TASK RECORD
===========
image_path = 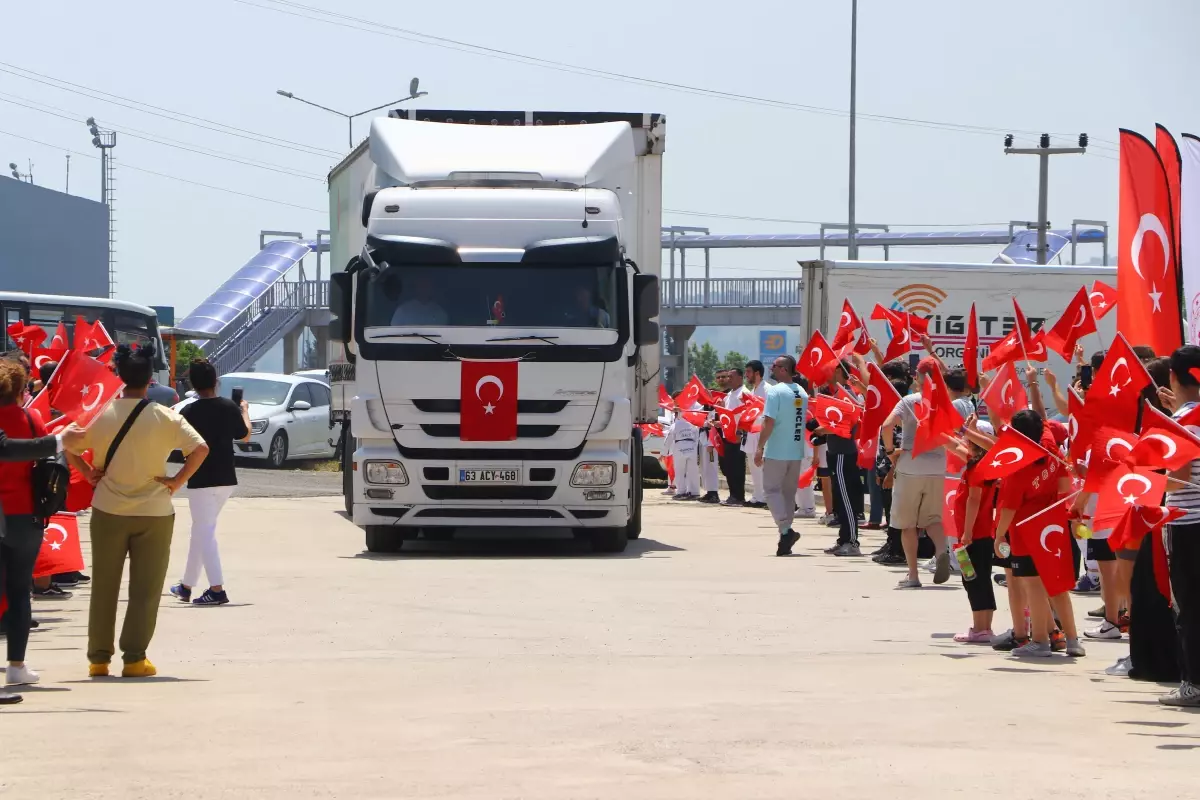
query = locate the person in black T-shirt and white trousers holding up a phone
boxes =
[170,359,250,606]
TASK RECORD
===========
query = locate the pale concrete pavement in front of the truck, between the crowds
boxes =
[0,492,1200,800]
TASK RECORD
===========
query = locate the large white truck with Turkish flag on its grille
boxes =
[330,110,666,552]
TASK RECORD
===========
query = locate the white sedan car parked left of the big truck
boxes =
[175,372,341,469]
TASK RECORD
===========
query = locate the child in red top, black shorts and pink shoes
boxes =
[954,422,1000,644]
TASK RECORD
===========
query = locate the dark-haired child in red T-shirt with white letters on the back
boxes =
[996,410,1086,657]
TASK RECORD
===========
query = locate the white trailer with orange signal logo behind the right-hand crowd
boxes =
[800,260,1118,386]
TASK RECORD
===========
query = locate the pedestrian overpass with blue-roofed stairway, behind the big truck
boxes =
[176,221,1108,373]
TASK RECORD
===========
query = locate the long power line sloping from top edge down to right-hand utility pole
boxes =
[233,0,1123,142]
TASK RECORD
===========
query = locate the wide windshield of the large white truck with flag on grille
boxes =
[366,263,617,330]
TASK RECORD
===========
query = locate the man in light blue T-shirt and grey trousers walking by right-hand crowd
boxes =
[754,355,809,555]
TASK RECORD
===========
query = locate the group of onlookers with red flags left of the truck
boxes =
[0,343,250,704]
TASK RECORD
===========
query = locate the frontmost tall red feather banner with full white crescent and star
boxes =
[1117,128,1183,354]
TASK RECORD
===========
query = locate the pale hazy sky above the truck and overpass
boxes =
[0,0,1200,314]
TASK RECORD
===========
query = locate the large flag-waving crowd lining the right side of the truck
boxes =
[665,319,1200,708]
